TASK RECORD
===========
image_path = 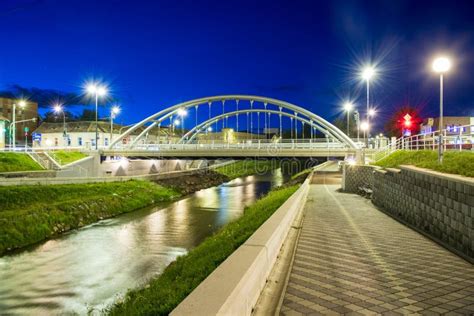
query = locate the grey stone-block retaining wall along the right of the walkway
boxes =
[343,166,474,262]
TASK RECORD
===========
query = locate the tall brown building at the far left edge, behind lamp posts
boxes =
[0,97,38,144]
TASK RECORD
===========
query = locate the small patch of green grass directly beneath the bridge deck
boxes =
[214,159,279,179]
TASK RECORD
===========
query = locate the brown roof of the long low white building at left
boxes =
[34,121,174,135]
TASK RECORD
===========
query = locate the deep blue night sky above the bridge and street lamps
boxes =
[0,0,474,129]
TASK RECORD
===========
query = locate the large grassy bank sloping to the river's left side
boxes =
[0,181,179,254]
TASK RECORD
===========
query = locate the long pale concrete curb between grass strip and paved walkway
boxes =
[171,173,312,315]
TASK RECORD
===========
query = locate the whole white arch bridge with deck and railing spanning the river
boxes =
[103,95,359,157]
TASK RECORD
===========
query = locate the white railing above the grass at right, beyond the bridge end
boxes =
[372,125,474,161]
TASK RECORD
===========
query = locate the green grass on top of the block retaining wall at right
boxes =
[374,150,474,177]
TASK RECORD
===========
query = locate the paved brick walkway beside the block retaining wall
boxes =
[281,179,474,315]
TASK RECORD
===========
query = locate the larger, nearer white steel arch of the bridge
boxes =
[109,94,358,149]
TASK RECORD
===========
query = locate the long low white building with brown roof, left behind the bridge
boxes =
[32,121,179,149]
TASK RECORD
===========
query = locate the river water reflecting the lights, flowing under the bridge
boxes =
[0,169,286,315]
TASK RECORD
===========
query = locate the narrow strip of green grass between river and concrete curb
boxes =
[106,185,298,315]
